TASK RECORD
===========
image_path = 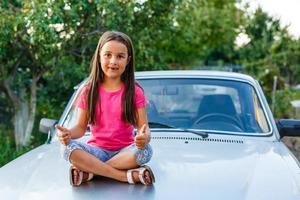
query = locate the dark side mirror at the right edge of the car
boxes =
[276,119,300,138]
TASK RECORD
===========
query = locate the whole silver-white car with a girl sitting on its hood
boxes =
[0,71,300,200]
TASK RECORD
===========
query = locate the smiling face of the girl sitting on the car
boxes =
[100,40,130,79]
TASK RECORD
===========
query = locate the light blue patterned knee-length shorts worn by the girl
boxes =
[63,140,153,165]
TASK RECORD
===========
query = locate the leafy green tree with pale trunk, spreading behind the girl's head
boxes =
[0,0,182,146]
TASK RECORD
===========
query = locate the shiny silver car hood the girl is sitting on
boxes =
[0,134,300,200]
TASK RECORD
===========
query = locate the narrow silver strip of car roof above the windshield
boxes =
[135,70,255,84]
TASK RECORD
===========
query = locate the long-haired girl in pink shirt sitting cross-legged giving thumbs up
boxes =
[56,31,155,186]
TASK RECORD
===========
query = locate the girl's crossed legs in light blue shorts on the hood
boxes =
[64,140,153,184]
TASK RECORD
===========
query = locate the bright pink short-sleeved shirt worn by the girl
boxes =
[76,85,147,150]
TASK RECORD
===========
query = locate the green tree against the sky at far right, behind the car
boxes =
[238,8,300,117]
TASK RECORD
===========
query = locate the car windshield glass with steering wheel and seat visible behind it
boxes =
[138,78,270,134]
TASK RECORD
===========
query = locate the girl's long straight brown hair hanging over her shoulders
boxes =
[87,31,137,125]
